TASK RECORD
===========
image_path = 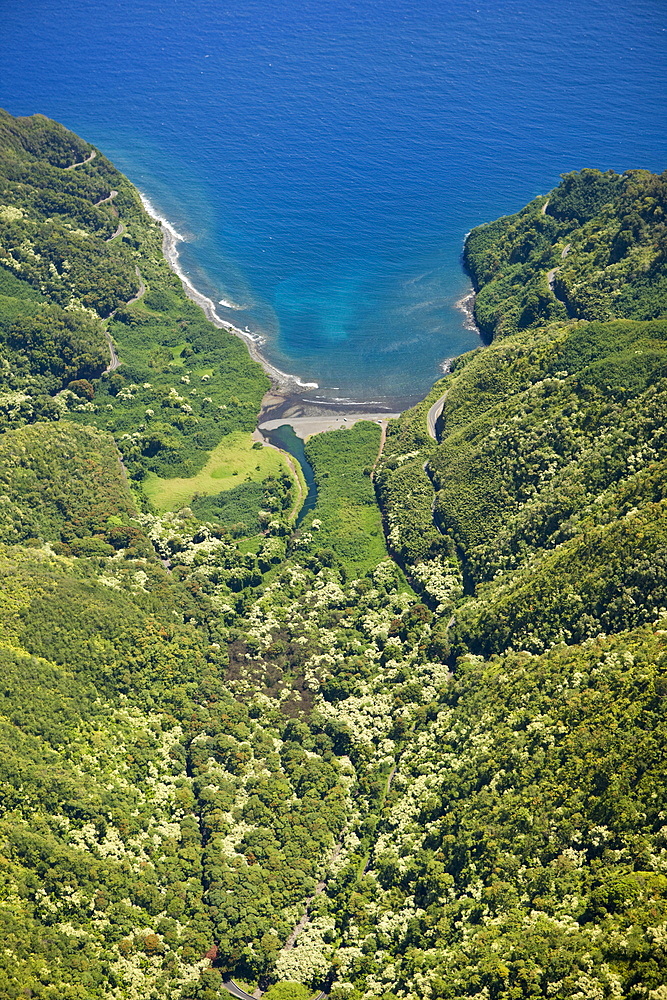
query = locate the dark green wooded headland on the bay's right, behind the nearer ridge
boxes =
[465,170,667,336]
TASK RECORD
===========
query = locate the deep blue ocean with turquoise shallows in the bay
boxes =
[0,0,667,403]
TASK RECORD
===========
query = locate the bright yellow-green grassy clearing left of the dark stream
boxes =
[143,431,286,512]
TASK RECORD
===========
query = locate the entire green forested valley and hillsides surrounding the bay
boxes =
[0,112,667,1000]
